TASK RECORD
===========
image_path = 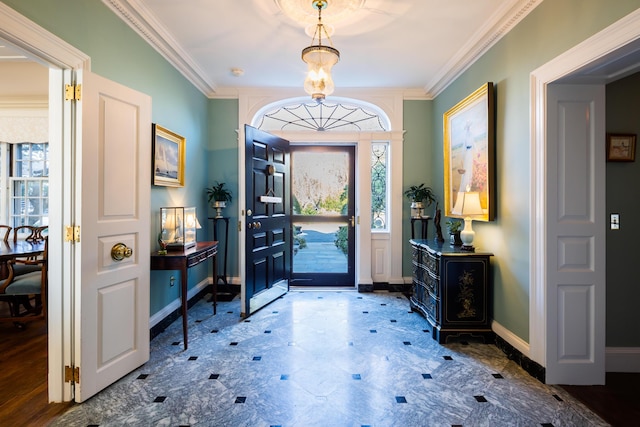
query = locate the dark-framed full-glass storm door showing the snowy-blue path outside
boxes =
[291,145,355,286]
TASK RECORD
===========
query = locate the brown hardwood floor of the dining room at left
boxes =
[0,320,72,427]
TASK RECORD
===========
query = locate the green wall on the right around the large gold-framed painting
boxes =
[432,0,640,341]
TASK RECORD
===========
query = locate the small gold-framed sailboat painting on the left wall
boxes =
[153,123,187,187]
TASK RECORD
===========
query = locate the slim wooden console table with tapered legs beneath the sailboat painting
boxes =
[151,241,218,350]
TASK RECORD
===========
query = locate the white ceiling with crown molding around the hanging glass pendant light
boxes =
[103,0,542,99]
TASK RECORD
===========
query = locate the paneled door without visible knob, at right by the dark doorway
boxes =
[546,85,606,385]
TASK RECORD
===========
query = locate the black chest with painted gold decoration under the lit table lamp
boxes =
[409,239,493,344]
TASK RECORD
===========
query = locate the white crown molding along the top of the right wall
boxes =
[424,0,543,99]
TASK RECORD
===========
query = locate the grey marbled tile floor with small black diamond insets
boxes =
[52,290,607,427]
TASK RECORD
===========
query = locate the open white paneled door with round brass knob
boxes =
[73,71,151,402]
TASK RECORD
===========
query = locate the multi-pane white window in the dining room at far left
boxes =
[9,143,49,231]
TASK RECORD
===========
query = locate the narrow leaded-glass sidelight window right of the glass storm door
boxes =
[371,142,389,231]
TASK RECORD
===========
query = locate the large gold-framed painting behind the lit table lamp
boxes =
[443,82,495,221]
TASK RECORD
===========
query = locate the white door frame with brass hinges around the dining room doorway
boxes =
[0,3,91,402]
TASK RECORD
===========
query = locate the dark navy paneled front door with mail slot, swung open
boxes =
[243,125,291,316]
